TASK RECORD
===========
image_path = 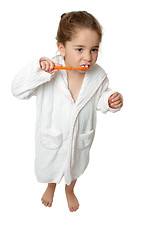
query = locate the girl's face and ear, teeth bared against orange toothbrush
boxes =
[58,29,100,73]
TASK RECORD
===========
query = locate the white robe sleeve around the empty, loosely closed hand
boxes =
[97,77,121,113]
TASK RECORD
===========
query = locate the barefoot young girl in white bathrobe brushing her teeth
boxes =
[12,11,122,212]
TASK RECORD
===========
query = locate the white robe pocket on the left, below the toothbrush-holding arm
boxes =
[40,130,62,149]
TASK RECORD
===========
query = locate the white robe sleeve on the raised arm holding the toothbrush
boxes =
[11,59,53,99]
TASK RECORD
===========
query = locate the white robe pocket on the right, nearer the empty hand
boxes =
[77,130,95,149]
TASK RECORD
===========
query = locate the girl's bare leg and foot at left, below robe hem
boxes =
[41,183,56,207]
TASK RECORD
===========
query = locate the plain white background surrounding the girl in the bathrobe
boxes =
[0,0,160,240]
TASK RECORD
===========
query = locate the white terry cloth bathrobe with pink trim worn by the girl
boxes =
[12,56,119,185]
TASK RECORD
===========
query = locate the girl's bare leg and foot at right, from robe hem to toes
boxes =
[65,180,79,212]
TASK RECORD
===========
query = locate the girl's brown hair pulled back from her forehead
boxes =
[56,11,102,46]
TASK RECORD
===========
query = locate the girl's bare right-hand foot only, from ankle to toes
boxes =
[66,191,79,212]
